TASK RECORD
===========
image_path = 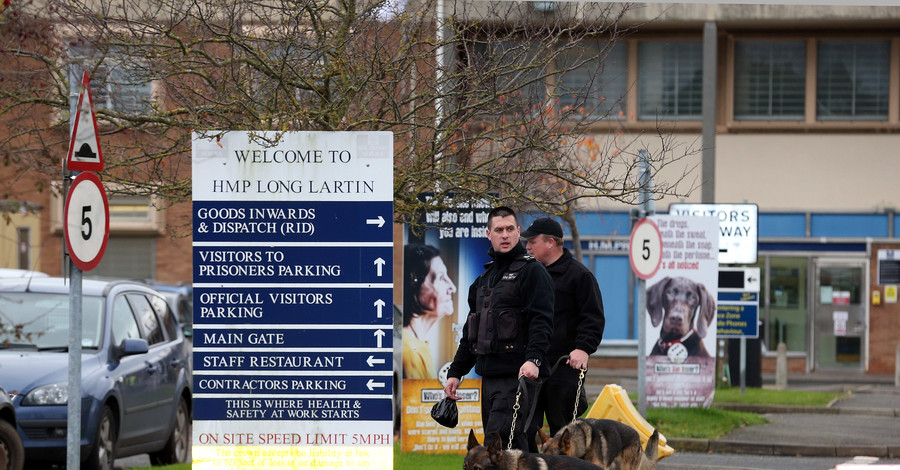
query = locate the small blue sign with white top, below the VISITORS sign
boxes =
[716,268,760,338]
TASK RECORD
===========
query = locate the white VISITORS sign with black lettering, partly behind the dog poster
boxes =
[669,204,759,264]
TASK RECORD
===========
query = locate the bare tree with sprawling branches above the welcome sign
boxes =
[0,0,695,234]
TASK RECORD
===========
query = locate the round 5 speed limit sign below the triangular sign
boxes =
[64,172,109,271]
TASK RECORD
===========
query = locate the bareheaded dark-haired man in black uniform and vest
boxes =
[444,206,553,451]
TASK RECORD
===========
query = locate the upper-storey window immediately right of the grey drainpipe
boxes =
[734,41,806,120]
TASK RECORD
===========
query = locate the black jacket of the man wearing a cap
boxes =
[547,248,606,366]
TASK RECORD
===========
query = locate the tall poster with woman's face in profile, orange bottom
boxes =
[400,205,491,454]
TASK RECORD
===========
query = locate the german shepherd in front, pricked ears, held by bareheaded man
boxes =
[463,430,602,470]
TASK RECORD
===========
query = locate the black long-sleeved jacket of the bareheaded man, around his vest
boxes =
[447,243,553,378]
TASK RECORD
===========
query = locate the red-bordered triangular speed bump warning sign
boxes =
[66,72,103,171]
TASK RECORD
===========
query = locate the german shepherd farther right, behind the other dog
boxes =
[539,418,659,470]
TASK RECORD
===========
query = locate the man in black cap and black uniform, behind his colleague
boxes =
[522,218,606,452]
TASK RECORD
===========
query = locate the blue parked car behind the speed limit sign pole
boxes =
[0,277,192,470]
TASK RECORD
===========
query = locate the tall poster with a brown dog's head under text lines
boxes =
[645,215,719,407]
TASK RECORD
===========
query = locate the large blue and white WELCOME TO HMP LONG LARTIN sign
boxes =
[192,131,393,469]
